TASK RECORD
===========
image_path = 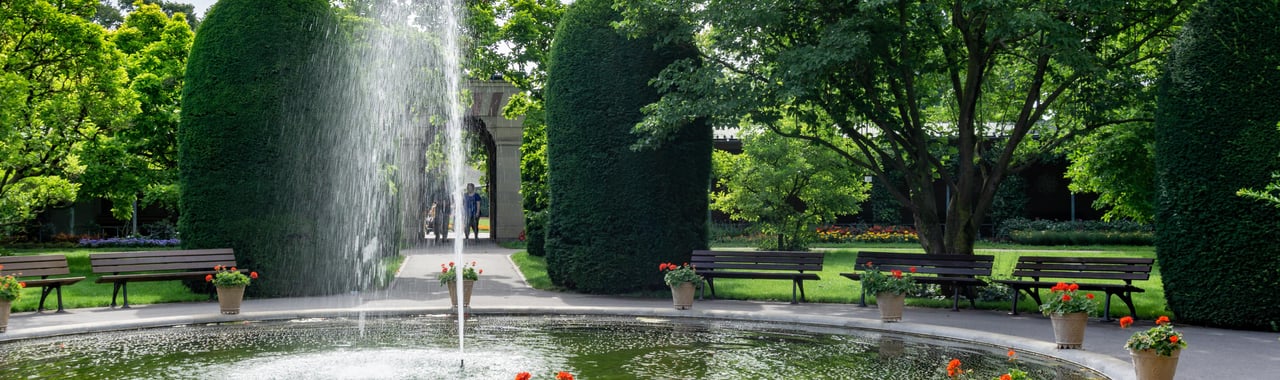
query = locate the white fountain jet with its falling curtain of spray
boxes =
[282,0,470,360]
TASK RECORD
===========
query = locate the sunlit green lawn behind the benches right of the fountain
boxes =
[512,243,1172,320]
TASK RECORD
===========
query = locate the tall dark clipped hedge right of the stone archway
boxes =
[545,0,712,293]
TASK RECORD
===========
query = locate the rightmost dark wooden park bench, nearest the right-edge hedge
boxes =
[996,256,1156,321]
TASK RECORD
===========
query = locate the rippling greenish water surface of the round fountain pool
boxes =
[0,315,1103,379]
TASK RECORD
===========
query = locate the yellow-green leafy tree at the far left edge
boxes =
[0,0,138,233]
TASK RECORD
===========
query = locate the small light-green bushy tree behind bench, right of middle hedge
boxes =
[712,122,870,251]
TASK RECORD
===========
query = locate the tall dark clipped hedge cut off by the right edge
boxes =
[1156,0,1280,329]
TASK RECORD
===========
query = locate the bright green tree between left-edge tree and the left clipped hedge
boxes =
[82,4,195,219]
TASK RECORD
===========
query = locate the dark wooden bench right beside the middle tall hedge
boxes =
[690,251,823,303]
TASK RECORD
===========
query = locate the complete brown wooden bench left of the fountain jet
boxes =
[88,248,236,308]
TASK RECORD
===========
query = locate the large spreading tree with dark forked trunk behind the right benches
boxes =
[621,0,1192,255]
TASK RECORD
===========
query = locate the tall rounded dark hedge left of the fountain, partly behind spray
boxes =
[178,0,360,296]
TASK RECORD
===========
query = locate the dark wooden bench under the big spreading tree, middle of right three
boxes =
[840,251,996,311]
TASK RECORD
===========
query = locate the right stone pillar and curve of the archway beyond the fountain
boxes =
[466,81,525,241]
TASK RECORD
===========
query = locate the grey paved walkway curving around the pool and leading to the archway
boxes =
[0,242,1280,380]
